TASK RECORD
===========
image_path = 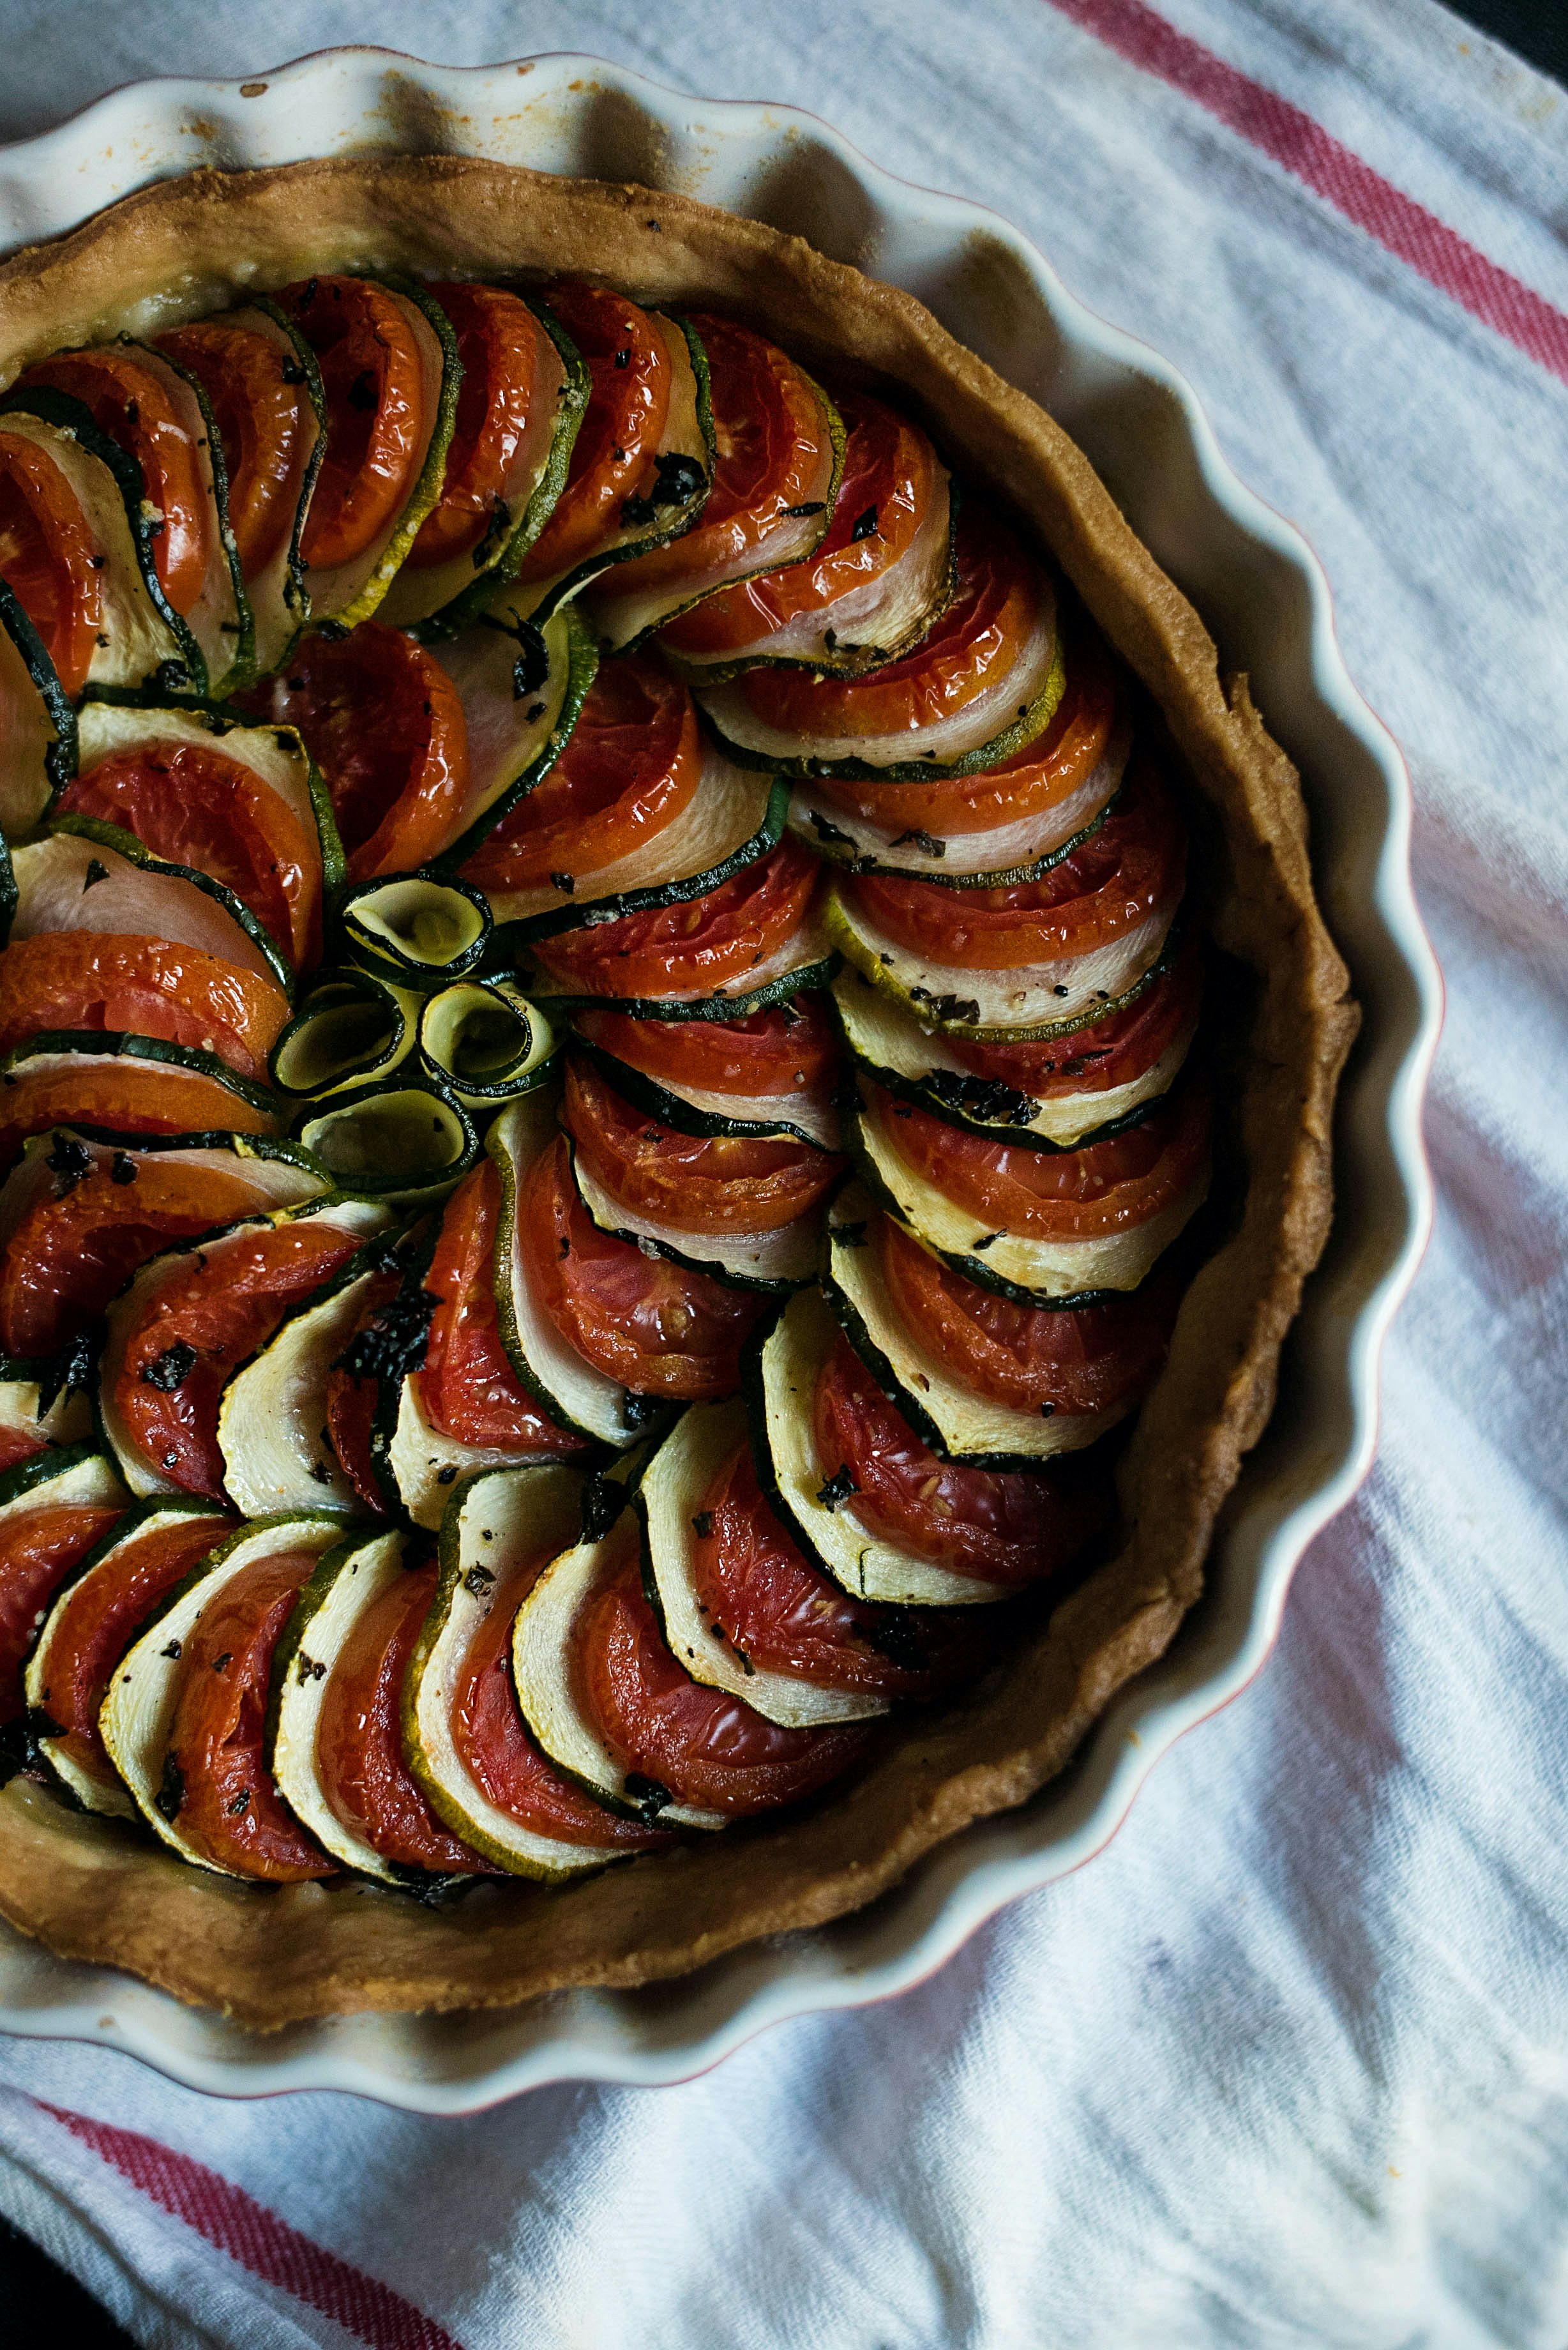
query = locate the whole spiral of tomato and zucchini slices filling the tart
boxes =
[0,277,1210,1894]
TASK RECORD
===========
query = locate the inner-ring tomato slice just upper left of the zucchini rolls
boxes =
[59,743,322,966]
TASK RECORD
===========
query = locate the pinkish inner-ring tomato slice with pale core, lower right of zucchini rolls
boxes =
[517,1137,769,1403]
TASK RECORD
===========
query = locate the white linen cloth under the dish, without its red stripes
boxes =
[0,0,1568,2350]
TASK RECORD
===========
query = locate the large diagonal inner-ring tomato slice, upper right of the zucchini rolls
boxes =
[463,653,703,891]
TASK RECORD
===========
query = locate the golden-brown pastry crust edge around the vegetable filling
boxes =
[0,158,1357,2026]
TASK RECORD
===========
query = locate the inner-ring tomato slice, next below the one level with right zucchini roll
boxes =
[562,1058,844,1231]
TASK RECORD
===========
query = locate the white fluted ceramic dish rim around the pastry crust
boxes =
[0,49,1441,2112]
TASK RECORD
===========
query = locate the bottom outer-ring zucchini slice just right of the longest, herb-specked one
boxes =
[513,1511,728,1828]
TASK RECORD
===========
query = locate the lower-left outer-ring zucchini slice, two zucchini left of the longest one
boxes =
[99,1511,343,1883]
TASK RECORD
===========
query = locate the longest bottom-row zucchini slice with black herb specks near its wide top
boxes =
[404,1469,649,1880]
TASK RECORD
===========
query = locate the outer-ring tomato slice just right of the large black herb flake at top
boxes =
[616,312,832,595]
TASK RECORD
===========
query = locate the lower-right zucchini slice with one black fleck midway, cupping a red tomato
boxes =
[748,1290,1016,1607]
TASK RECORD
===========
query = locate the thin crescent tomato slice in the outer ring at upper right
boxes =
[813,630,1117,839]
